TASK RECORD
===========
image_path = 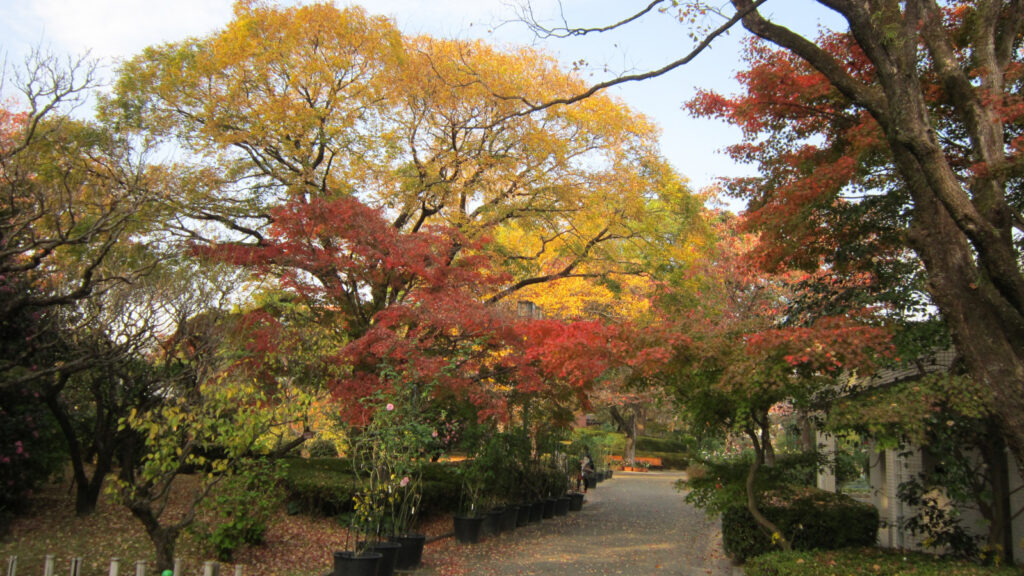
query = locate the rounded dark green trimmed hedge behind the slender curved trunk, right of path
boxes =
[722,490,879,563]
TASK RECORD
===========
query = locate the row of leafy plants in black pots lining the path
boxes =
[333,378,610,576]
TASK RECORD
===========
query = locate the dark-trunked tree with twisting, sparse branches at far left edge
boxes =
[0,50,190,513]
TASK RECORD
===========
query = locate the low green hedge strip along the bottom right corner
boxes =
[743,548,1020,576]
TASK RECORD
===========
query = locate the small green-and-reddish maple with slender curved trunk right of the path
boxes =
[663,221,890,547]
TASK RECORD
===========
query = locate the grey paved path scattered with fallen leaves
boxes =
[418,472,742,576]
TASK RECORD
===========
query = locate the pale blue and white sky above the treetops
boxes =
[0,0,835,196]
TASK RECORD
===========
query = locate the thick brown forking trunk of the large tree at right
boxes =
[732,0,1024,483]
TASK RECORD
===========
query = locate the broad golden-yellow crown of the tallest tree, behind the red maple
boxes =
[106,3,675,315]
